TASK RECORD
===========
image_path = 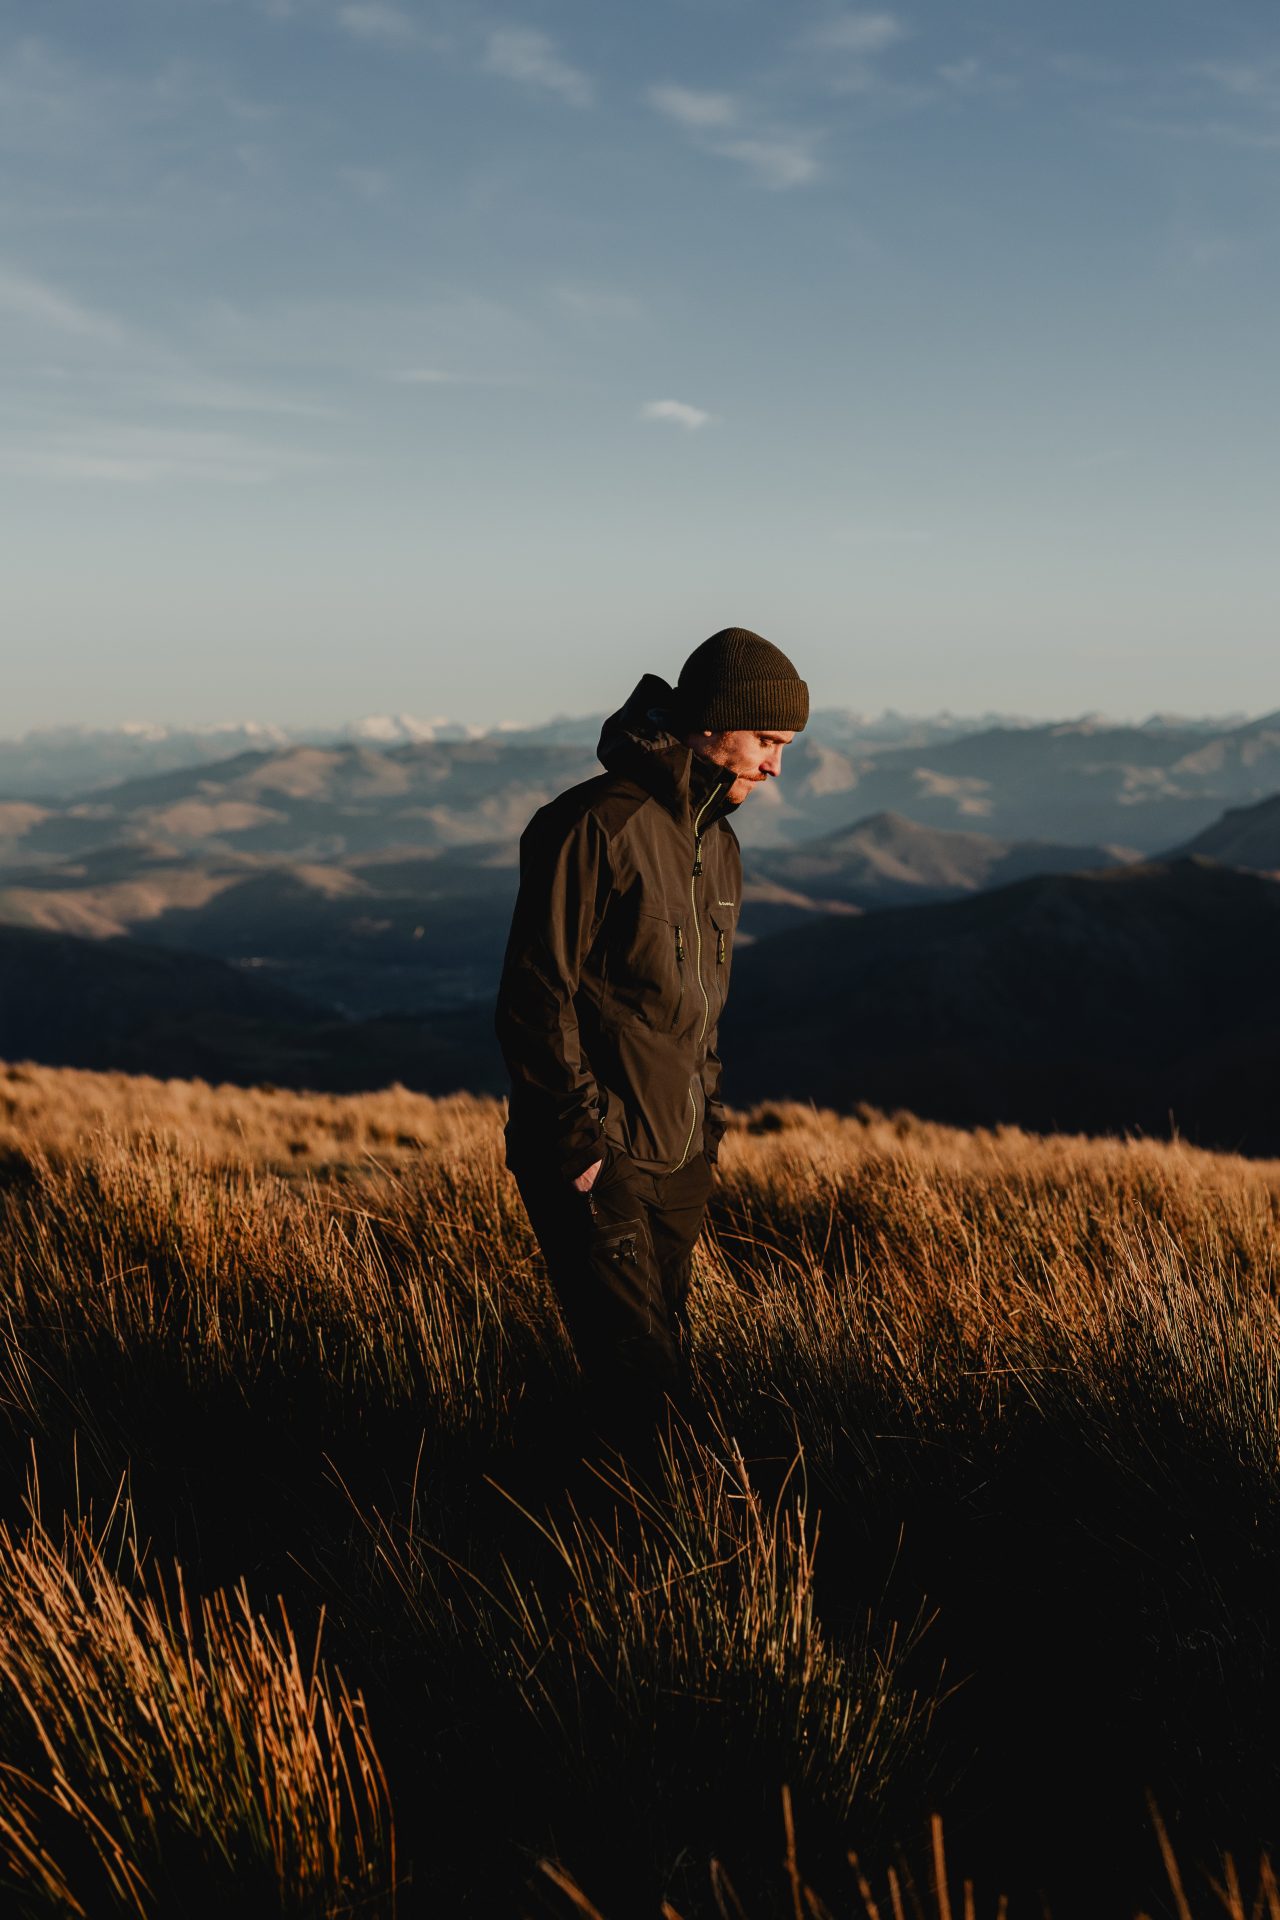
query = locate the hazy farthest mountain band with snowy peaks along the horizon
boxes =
[0,706,1280,868]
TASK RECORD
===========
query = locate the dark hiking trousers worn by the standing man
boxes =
[509,1140,712,1436]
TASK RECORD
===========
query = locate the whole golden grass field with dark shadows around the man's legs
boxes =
[0,1068,1280,1920]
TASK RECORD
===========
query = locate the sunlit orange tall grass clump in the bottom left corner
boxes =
[0,1513,397,1920]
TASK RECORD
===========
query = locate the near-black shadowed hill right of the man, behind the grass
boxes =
[722,860,1280,1152]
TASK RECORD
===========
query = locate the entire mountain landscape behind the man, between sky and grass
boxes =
[0,714,1280,1150]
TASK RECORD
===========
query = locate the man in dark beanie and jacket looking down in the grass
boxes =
[497,626,808,1444]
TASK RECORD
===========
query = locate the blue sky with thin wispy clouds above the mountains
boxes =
[0,0,1280,733]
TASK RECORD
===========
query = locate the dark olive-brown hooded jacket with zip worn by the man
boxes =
[497,674,743,1179]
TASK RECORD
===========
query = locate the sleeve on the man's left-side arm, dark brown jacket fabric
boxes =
[497,814,612,1179]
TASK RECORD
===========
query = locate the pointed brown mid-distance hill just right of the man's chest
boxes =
[745,814,1126,925]
